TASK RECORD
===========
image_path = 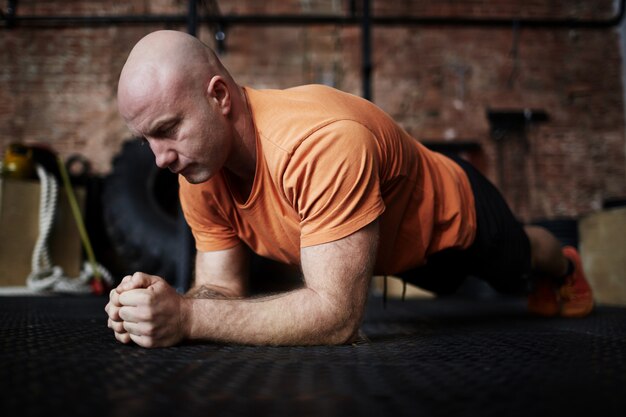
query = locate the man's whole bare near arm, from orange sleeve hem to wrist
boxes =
[181,221,378,345]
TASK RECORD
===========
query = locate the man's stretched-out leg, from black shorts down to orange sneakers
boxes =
[442,156,593,317]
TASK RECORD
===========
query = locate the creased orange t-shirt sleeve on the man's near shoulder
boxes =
[283,120,385,247]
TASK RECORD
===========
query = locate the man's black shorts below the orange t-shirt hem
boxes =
[398,156,531,295]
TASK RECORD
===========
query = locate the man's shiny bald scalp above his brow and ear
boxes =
[117,30,235,120]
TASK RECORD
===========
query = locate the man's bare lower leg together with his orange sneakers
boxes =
[524,226,593,317]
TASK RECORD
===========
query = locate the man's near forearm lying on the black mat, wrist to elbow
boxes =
[179,288,364,345]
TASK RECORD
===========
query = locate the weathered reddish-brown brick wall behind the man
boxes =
[0,0,626,220]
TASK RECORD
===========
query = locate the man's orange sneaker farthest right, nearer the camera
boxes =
[559,246,593,317]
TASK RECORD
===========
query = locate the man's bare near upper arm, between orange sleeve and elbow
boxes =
[302,220,378,326]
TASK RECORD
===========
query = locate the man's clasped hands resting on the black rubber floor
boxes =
[104,272,185,347]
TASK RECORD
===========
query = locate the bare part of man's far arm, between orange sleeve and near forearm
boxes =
[194,244,249,297]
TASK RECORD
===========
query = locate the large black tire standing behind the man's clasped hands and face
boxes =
[102,140,189,290]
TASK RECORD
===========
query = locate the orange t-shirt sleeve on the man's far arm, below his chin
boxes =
[178,176,240,252]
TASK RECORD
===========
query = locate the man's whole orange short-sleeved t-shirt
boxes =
[180,85,476,274]
